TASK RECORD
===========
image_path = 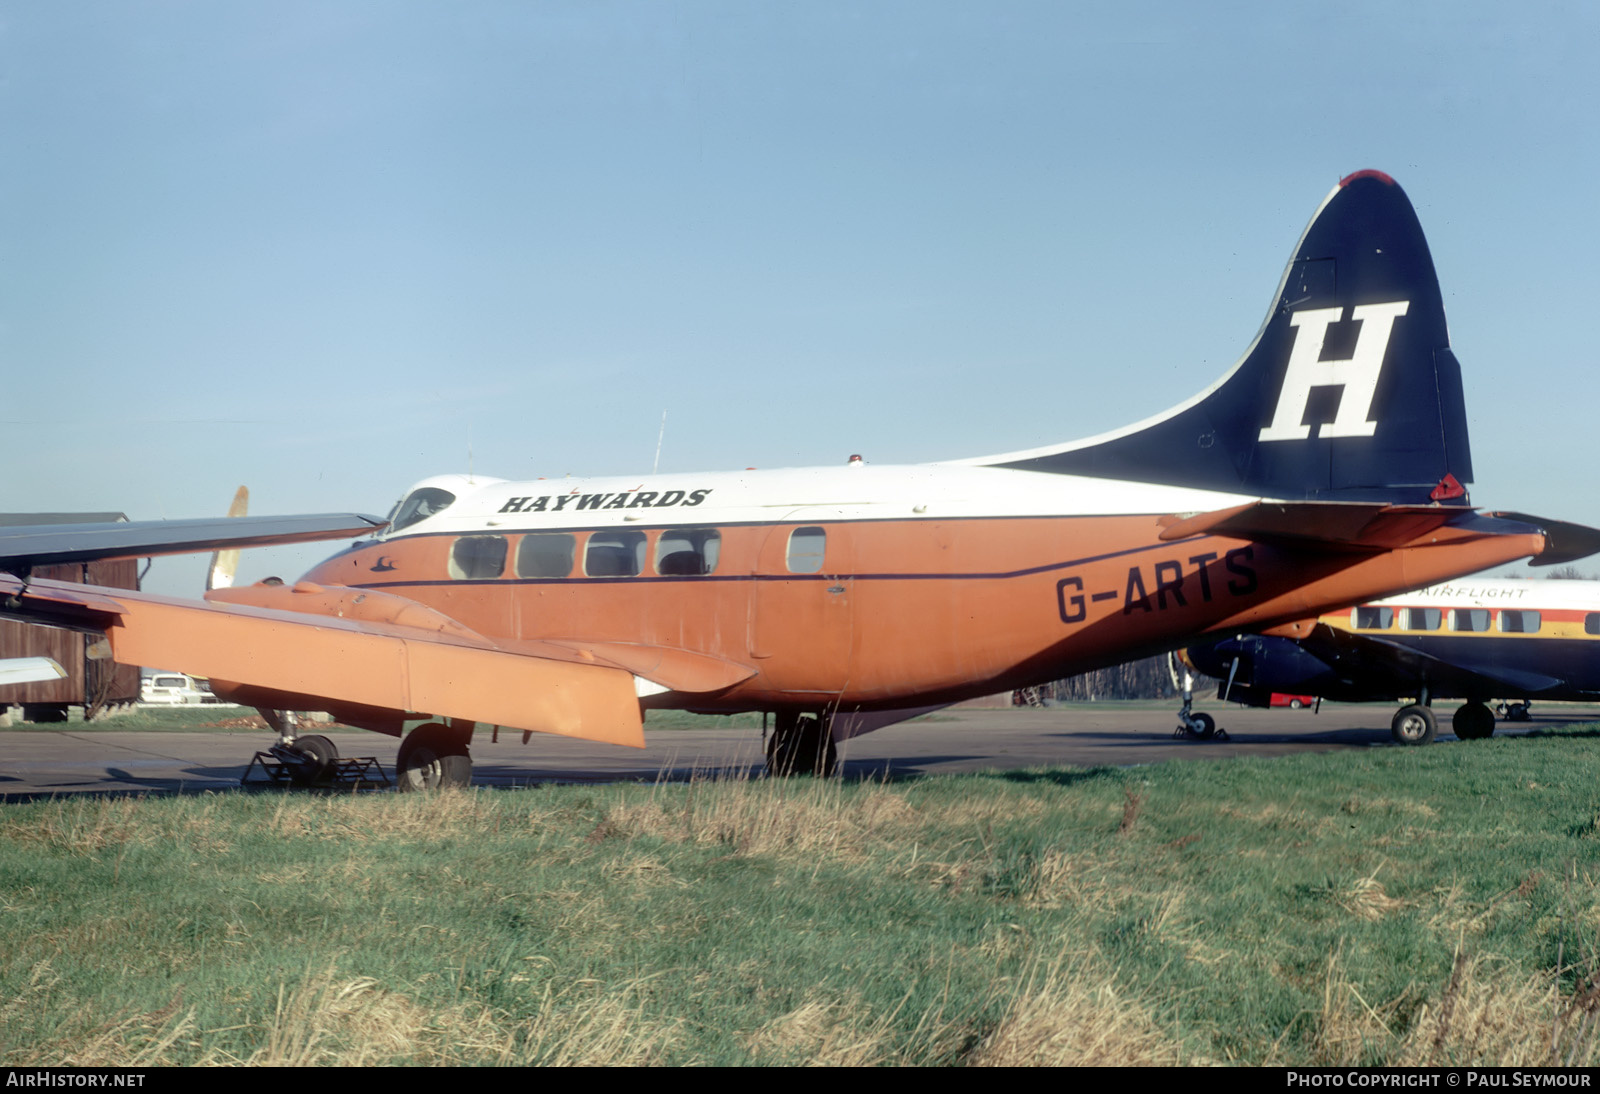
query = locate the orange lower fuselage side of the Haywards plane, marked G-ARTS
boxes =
[284,502,1539,710]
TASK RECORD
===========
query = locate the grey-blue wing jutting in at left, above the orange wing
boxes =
[0,513,384,573]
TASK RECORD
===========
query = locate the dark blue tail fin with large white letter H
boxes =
[971,171,1472,502]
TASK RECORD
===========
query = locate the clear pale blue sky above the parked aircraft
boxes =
[0,0,1600,592]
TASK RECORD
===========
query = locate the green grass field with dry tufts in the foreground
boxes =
[0,729,1600,1065]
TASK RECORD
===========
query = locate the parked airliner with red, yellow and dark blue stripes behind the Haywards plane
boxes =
[1187,579,1600,745]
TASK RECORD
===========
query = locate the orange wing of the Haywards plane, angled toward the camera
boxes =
[0,574,665,747]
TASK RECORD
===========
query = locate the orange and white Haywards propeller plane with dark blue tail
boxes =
[0,171,1600,787]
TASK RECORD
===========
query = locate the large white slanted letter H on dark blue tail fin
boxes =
[1259,301,1411,440]
